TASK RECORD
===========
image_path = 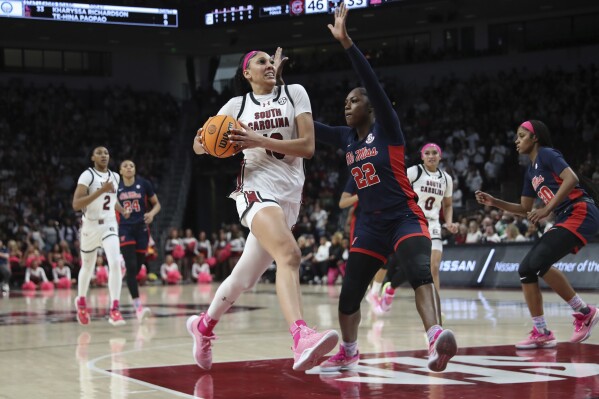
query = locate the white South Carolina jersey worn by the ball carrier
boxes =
[218,84,312,202]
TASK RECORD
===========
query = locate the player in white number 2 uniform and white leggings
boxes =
[73,146,131,326]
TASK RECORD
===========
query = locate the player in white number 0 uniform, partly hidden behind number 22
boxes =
[376,143,458,314]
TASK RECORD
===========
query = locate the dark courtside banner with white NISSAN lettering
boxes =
[440,243,599,289]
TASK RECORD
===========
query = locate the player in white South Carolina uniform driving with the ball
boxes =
[187,50,338,370]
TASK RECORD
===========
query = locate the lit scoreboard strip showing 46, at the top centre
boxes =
[204,0,404,25]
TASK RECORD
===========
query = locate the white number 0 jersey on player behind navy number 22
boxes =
[407,165,453,221]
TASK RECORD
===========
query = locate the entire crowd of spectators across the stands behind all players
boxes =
[0,57,599,290]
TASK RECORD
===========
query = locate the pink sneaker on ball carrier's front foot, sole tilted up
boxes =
[293,326,339,371]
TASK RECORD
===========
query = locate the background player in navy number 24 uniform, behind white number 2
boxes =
[117,159,161,322]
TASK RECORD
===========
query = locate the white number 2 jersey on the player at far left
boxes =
[77,168,121,220]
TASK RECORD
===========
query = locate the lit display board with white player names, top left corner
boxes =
[0,0,179,28]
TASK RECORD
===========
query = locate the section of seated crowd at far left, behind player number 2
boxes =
[0,80,180,292]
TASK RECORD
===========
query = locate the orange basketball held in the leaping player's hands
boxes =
[201,115,241,158]
